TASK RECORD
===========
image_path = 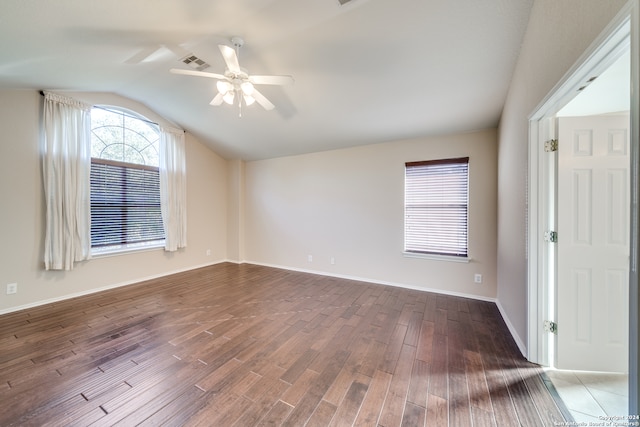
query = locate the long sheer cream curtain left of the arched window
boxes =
[42,92,91,270]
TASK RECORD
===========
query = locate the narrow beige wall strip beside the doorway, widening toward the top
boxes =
[498,0,626,352]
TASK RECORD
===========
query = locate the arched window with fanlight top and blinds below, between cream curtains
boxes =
[91,106,164,253]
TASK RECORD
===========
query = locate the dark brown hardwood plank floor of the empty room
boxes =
[0,264,563,427]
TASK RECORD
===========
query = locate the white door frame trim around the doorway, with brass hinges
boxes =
[527,0,640,414]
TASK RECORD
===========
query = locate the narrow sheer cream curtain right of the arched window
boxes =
[160,128,187,252]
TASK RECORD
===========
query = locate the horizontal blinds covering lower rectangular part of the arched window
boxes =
[91,158,164,248]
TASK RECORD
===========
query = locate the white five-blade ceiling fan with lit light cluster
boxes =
[169,37,293,114]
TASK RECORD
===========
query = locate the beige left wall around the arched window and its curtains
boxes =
[0,90,227,313]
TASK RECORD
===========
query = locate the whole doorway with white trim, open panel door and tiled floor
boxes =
[527,1,639,422]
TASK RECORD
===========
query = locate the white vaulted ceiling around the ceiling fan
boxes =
[0,0,533,160]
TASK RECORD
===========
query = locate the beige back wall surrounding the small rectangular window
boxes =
[244,130,497,298]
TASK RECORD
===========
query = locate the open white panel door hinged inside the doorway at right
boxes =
[557,114,630,372]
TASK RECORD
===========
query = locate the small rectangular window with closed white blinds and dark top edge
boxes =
[404,157,469,257]
